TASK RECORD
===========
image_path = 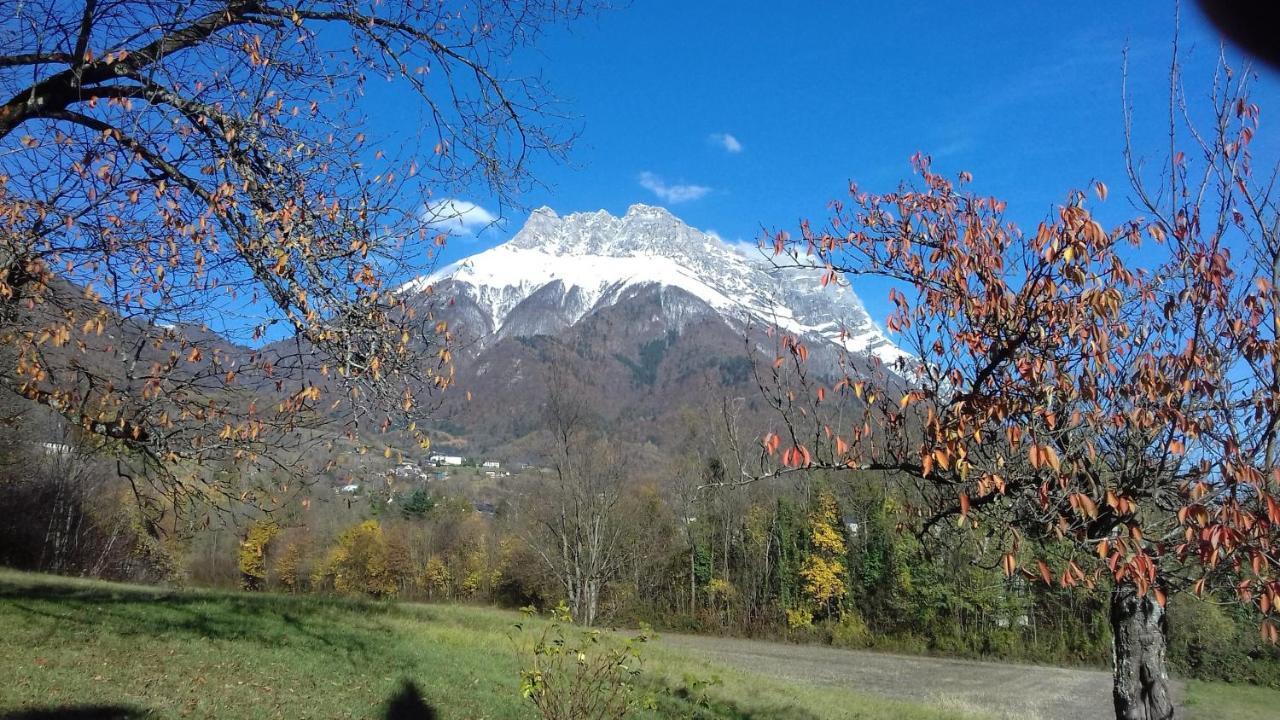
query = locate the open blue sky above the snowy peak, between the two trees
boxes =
[386,0,1280,320]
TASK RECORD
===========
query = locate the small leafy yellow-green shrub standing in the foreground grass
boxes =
[511,602,655,720]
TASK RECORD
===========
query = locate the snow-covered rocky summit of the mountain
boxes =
[401,205,906,363]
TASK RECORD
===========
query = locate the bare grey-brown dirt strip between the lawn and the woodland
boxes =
[659,634,1181,720]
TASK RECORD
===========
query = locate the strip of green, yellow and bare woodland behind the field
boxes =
[0,389,1280,688]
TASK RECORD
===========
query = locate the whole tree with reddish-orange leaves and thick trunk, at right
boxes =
[742,50,1280,720]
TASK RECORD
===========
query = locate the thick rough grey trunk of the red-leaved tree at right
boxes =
[1111,584,1174,720]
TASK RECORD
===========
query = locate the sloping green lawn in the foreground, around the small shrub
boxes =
[0,570,972,720]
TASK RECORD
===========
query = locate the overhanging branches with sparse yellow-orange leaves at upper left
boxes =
[0,0,584,515]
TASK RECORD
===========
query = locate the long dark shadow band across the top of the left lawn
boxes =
[0,571,396,661]
